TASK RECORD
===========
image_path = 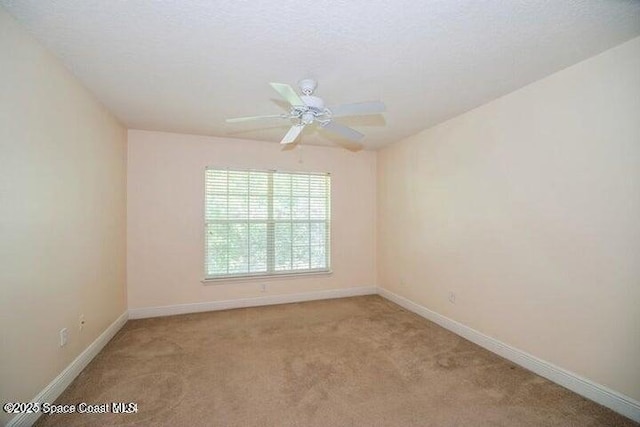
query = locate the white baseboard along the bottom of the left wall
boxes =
[7,311,129,427]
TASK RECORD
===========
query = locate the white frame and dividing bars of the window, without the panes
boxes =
[202,166,332,284]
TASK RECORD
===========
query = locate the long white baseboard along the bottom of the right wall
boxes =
[378,288,640,422]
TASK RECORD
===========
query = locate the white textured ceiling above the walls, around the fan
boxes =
[0,0,640,148]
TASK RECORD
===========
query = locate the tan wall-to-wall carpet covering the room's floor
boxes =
[33,296,636,427]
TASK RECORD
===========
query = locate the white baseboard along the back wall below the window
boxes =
[129,286,378,319]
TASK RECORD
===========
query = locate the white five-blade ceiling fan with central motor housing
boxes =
[226,79,385,144]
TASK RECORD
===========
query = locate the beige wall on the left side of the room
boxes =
[0,8,126,424]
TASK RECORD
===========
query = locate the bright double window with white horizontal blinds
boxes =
[204,168,331,279]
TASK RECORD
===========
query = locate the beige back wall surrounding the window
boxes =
[127,130,376,309]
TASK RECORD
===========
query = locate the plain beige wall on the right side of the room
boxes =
[378,38,640,400]
